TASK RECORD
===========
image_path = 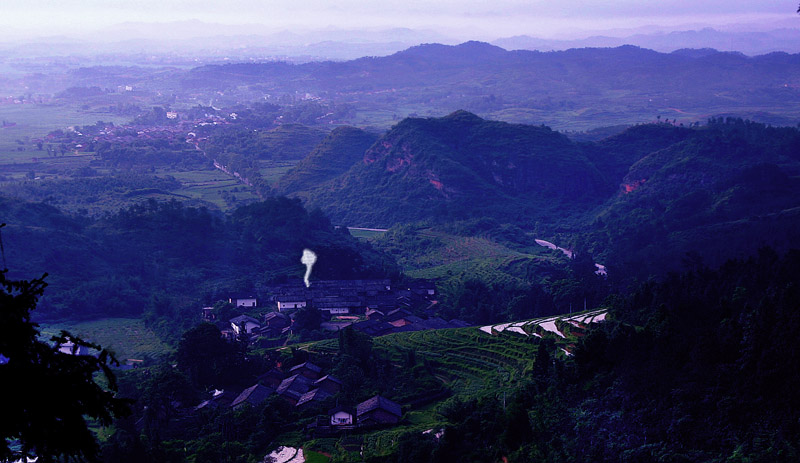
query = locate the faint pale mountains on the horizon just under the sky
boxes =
[6,20,800,61]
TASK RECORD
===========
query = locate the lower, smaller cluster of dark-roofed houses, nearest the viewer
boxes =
[195,362,403,433]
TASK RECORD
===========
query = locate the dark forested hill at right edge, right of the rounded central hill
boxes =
[587,119,800,273]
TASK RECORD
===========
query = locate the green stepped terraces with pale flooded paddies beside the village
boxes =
[298,310,606,458]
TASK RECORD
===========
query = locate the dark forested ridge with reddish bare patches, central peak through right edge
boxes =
[284,111,800,280]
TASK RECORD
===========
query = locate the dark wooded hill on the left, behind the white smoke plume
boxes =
[0,198,396,322]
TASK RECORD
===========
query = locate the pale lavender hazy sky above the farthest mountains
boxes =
[0,0,800,38]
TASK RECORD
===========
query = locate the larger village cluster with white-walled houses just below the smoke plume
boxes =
[203,279,469,338]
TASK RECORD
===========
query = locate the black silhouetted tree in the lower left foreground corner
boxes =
[0,270,130,462]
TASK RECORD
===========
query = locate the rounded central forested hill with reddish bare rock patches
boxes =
[310,111,606,226]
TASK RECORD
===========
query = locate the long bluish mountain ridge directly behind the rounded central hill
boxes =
[183,42,800,130]
